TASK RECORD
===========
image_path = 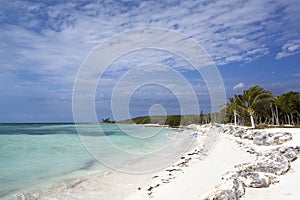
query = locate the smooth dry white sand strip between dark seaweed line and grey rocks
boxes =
[127,131,255,200]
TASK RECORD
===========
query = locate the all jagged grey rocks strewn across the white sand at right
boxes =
[205,128,300,200]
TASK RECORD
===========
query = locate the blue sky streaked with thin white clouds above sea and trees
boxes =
[0,0,300,122]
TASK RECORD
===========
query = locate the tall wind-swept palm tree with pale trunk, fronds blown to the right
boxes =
[235,85,273,128]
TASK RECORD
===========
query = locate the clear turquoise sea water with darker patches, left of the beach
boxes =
[0,124,180,198]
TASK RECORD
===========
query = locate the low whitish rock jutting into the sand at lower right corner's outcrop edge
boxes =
[239,171,277,188]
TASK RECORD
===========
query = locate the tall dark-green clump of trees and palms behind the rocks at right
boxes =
[220,85,300,128]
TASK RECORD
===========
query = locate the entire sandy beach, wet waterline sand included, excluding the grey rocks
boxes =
[3,125,300,200]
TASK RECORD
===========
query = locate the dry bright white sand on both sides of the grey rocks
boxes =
[125,127,300,200]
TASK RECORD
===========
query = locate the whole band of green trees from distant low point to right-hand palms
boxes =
[119,85,300,128]
